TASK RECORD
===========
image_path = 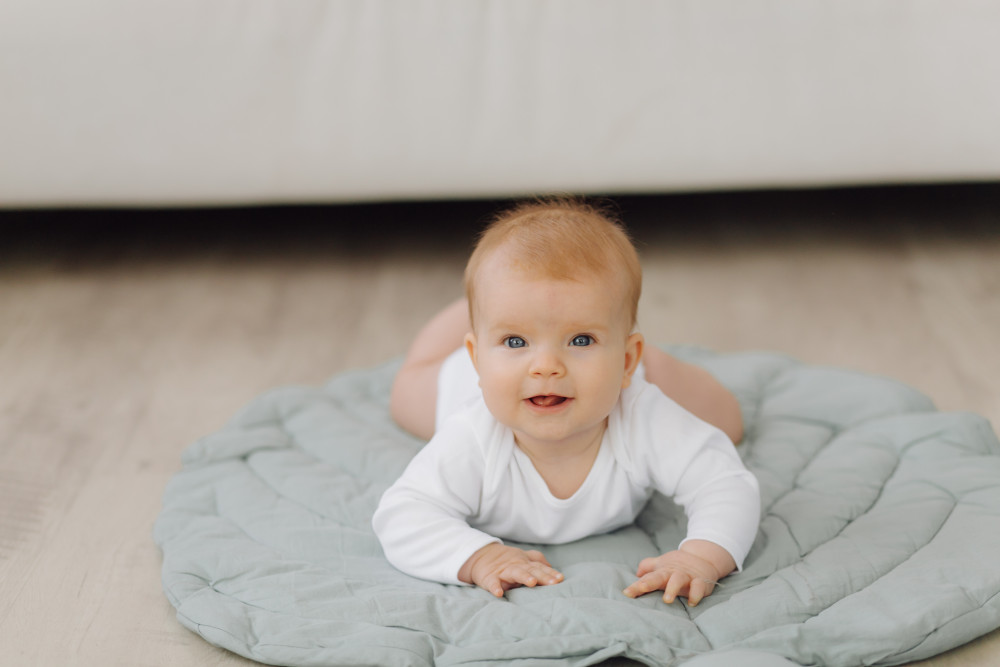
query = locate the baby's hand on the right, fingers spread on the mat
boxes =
[623,540,736,607]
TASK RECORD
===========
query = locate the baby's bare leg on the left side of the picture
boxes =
[389,299,471,440]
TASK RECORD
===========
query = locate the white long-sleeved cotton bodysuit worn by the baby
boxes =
[372,350,760,584]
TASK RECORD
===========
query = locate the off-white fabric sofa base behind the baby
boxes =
[0,0,1000,208]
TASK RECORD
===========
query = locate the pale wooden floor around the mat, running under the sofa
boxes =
[0,186,1000,667]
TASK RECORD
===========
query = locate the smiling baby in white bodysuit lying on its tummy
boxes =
[373,200,760,605]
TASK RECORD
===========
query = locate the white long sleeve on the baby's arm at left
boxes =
[372,419,500,584]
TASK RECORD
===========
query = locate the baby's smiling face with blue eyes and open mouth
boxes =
[466,256,643,449]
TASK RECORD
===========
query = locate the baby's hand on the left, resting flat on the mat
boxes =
[458,542,563,598]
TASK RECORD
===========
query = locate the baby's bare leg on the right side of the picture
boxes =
[642,345,743,443]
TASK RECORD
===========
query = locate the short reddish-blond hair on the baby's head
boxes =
[465,197,642,330]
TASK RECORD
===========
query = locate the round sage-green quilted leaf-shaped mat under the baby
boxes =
[154,347,1000,667]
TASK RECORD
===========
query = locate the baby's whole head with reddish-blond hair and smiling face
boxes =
[465,200,643,451]
